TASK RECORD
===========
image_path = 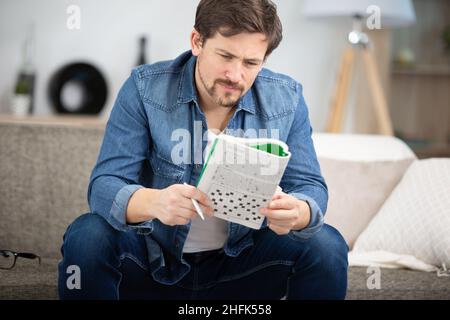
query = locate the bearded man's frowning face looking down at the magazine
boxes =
[191,30,268,107]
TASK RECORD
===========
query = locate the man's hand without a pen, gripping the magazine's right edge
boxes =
[260,192,311,235]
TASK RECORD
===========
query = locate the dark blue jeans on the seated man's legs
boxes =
[58,213,348,300]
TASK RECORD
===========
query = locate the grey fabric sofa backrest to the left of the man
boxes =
[0,123,103,257]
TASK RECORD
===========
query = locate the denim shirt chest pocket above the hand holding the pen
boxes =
[150,150,186,189]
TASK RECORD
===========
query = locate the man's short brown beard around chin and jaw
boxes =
[197,61,244,108]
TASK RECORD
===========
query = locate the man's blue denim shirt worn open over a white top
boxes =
[88,51,328,284]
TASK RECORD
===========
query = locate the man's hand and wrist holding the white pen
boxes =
[127,184,213,226]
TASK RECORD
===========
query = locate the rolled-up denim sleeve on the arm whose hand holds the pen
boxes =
[87,71,153,233]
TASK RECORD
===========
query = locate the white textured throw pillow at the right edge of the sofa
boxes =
[353,159,450,266]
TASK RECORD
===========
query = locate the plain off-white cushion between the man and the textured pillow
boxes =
[313,133,416,248]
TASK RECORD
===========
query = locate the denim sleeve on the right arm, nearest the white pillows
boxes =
[280,85,328,239]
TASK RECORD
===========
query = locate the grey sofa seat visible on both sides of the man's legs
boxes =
[0,259,450,300]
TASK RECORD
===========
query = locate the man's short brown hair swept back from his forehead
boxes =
[194,0,283,57]
